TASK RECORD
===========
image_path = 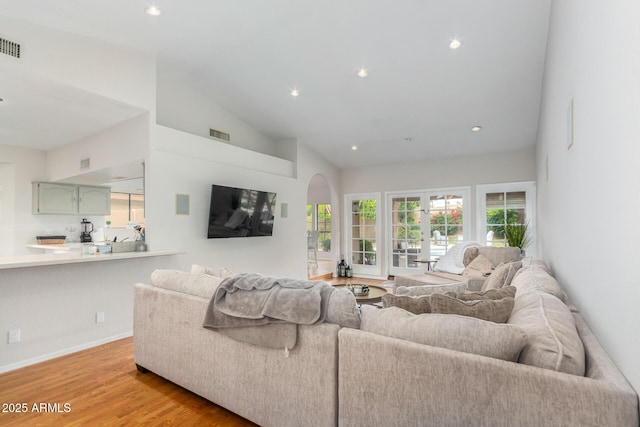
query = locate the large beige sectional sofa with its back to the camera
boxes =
[134,259,639,426]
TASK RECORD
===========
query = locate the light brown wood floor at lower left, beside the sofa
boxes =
[0,338,255,427]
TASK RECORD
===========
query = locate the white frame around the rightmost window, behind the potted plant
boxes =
[476,181,537,256]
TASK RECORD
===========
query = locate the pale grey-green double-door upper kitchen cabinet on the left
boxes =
[32,182,111,215]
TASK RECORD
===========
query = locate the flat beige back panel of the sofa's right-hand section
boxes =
[338,329,638,426]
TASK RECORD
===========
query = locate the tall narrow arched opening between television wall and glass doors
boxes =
[307,175,337,278]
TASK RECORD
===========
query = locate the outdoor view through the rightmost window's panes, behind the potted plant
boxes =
[486,191,526,247]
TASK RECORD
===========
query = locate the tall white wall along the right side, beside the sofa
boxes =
[537,0,640,390]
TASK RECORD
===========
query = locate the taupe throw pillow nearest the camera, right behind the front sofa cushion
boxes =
[430,294,513,323]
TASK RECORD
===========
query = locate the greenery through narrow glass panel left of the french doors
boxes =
[351,199,377,265]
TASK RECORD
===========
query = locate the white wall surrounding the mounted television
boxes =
[145,126,337,278]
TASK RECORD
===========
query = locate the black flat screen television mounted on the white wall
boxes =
[207,185,276,239]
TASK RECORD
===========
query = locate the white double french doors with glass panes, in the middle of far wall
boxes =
[387,187,469,276]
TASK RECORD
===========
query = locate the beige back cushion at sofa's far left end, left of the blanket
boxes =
[151,269,222,299]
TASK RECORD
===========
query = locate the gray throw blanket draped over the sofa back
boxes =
[203,273,334,330]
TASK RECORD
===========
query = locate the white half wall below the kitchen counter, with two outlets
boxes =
[0,255,180,372]
